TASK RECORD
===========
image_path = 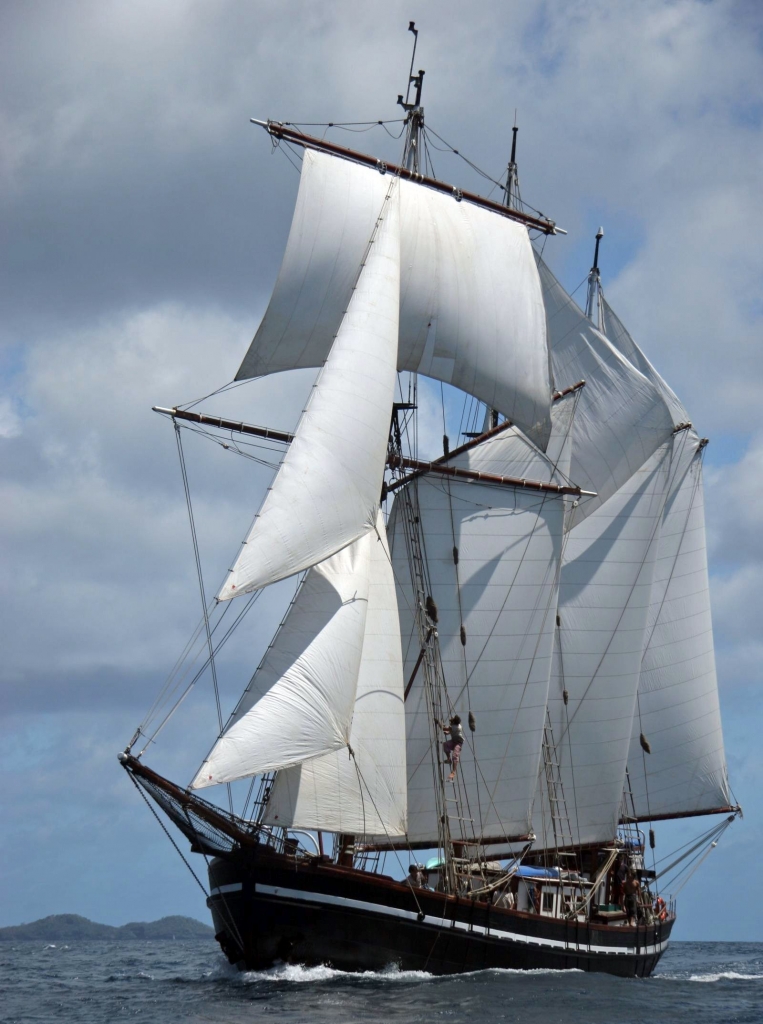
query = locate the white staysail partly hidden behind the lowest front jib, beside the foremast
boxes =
[263,513,407,837]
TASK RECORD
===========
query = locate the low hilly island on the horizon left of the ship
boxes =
[0,913,214,942]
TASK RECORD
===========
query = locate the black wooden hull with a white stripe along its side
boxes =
[207,849,675,978]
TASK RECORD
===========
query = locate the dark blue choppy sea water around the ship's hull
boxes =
[0,941,763,1024]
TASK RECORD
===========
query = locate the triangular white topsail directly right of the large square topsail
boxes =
[538,251,675,523]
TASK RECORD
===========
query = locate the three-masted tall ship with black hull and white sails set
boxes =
[120,23,740,976]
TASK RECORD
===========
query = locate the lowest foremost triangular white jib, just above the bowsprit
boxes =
[192,535,372,790]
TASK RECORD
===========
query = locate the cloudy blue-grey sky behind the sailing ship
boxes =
[0,0,763,940]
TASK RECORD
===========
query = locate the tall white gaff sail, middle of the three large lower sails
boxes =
[535,446,670,848]
